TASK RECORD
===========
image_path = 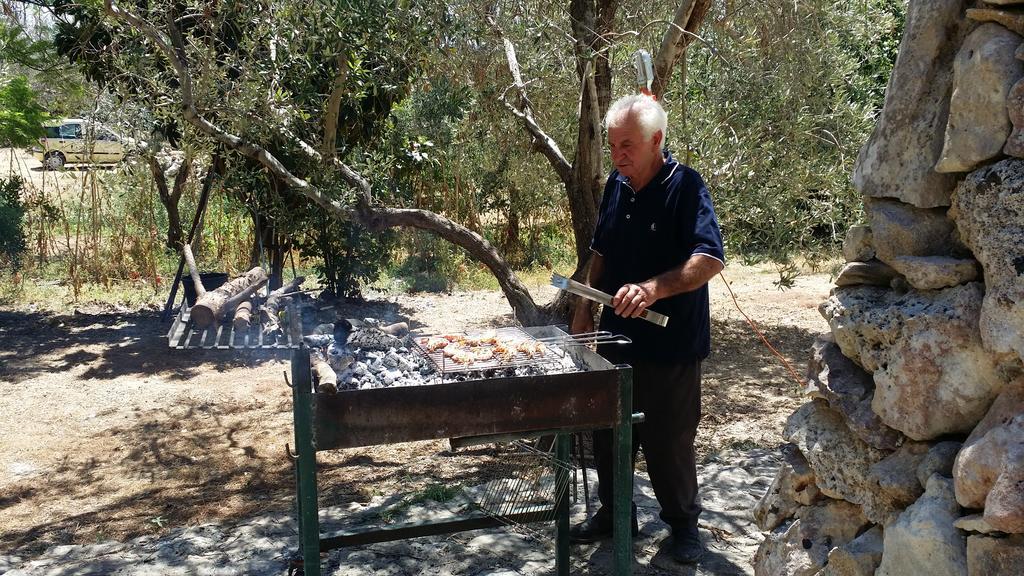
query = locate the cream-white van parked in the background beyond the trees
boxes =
[32,118,130,170]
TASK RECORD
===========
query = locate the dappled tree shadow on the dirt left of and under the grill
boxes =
[0,389,557,557]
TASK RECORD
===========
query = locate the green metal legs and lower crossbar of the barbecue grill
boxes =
[291,346,633,576]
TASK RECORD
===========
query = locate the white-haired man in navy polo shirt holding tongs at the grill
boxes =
[570,94,725,563]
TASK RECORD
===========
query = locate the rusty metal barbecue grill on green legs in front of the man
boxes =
[291,326,633,576]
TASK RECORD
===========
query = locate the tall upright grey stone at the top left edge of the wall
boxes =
[853,0,974,208]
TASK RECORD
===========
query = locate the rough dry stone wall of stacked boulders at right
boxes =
[754,0,1024,576]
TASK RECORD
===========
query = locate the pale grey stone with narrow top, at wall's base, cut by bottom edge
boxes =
[876,476,967,576]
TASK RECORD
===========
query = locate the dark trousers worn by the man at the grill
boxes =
[594,355,700,531]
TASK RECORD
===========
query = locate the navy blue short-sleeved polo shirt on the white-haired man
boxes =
[591,152,725,362]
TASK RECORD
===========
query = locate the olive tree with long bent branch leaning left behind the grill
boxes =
[92,0,711,324]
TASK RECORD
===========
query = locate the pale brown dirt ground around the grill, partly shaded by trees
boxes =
[0,265,830,558]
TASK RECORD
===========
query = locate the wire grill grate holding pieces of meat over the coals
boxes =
[413,326,565,374]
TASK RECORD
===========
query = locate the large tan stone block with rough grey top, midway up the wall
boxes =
[819,283,1007,438]
